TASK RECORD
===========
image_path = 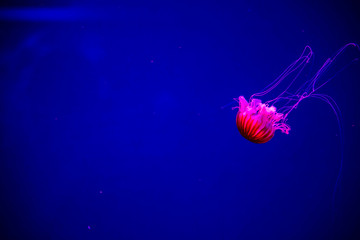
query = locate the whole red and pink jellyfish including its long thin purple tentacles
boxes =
[233,43,360,143]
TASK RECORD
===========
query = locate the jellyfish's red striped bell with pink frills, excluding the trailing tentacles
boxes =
[235,96,290,143]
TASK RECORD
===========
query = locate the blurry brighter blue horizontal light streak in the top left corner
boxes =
[0,8,98,21]
